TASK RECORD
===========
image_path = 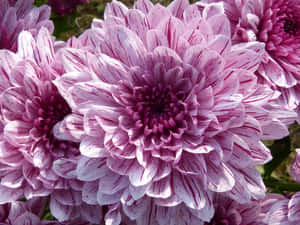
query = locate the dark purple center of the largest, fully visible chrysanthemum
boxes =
[131,84,185,136]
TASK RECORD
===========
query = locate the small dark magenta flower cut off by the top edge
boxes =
[48,0,89,16]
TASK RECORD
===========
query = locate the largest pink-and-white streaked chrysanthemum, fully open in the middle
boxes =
[54,0,295,221]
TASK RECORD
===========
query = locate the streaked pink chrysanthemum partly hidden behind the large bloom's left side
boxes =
[0,28,102,223]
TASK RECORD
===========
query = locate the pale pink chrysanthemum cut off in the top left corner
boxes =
[0,0,53,51]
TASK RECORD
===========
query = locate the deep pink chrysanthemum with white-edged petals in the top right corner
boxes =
[206,0,300,112]
